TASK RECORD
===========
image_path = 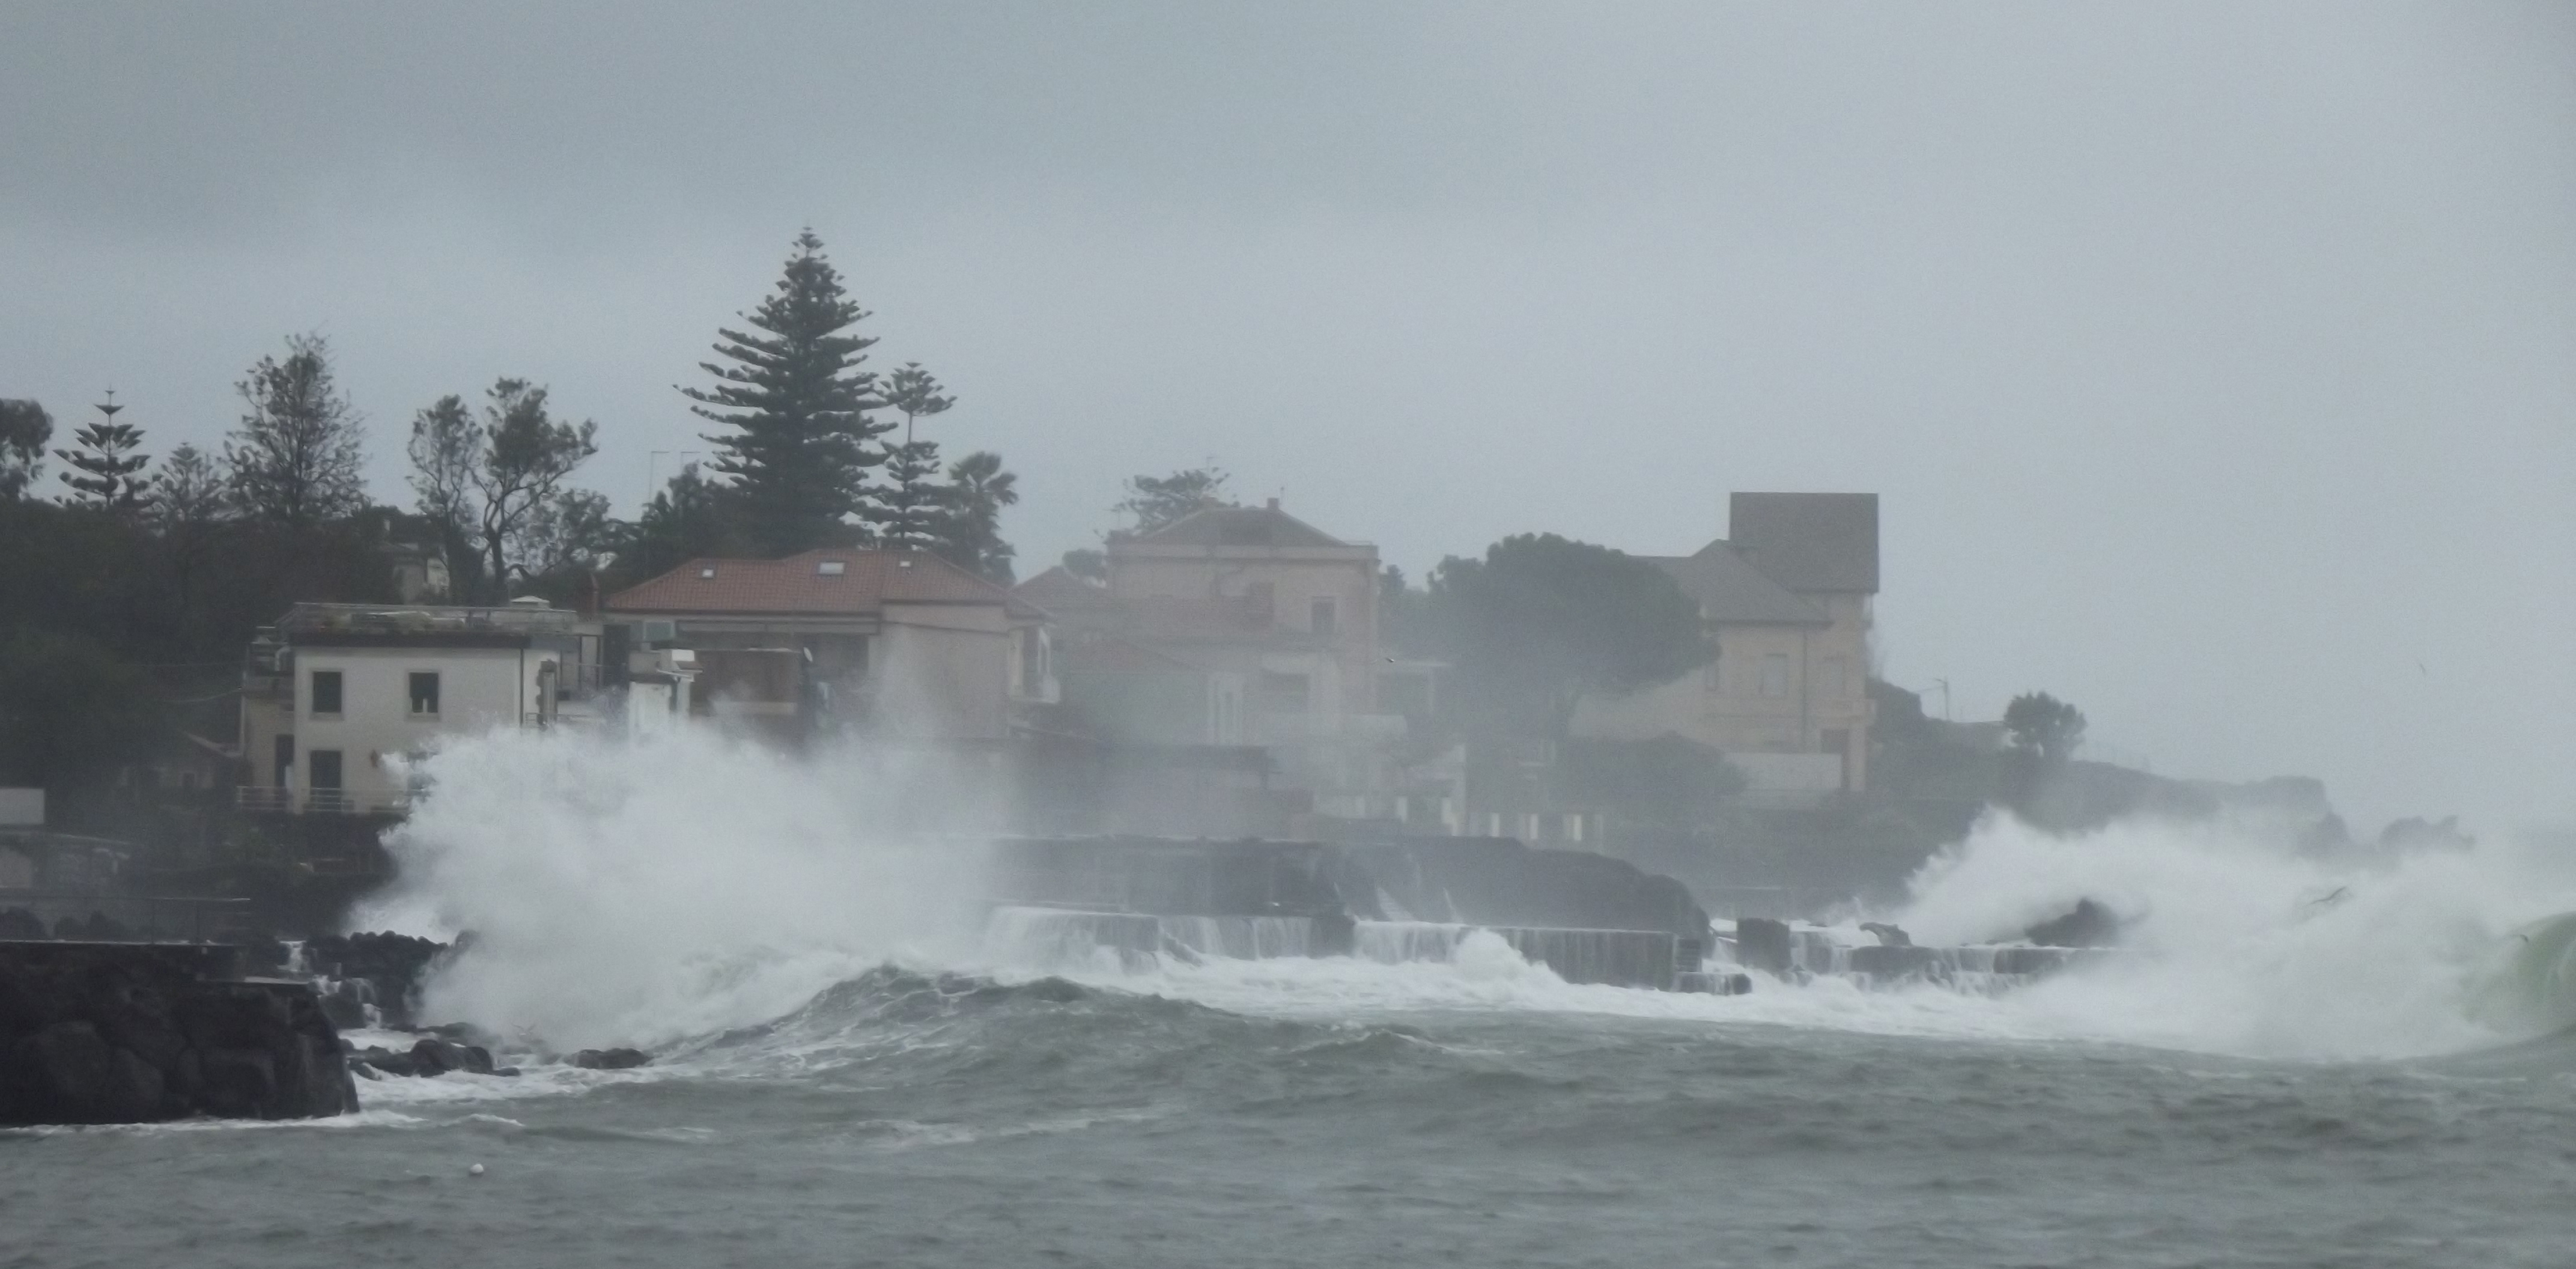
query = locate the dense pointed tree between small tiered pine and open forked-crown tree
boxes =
[224,335,366,528]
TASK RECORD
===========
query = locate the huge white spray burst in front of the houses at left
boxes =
[353,728,982,1048]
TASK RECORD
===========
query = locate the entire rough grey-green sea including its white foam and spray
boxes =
[0,739,2576,1267]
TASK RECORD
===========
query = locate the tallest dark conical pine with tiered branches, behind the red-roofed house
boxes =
[680,229,894,556]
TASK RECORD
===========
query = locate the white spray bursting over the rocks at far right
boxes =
[1901,816,2576,1058]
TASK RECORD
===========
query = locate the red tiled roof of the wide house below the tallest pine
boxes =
[606,548,1033,615]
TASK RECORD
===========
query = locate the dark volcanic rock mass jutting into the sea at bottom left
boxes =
[0,942,358,1125]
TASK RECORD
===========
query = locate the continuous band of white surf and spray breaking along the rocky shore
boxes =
[356,731,2576,1066]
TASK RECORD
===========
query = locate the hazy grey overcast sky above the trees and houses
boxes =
[0,0,2576,829]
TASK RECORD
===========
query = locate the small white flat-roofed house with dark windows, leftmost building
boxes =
[237,597,603,814]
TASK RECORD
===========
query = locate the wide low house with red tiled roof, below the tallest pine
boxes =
[603,548,1059,741]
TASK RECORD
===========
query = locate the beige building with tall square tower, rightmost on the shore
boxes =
[1574,495,1878,800]
